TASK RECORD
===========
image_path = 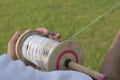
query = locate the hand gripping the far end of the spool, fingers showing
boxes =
[8,27,61,60]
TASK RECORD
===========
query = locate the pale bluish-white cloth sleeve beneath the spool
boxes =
[0,54,92,80]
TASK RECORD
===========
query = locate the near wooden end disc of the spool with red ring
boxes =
[47,41,84,71]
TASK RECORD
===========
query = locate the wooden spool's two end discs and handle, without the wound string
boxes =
[16,31,106,80]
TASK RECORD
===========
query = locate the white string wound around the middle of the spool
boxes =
[21,35,60,68]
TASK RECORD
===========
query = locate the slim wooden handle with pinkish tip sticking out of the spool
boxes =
[68,61,106,80]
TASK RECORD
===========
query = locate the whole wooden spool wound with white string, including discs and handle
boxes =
[16,31,106,80]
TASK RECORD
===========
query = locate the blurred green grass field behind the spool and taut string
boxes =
[0,0,120,70]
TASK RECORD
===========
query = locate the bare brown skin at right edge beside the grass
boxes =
[100,30,120,80]
